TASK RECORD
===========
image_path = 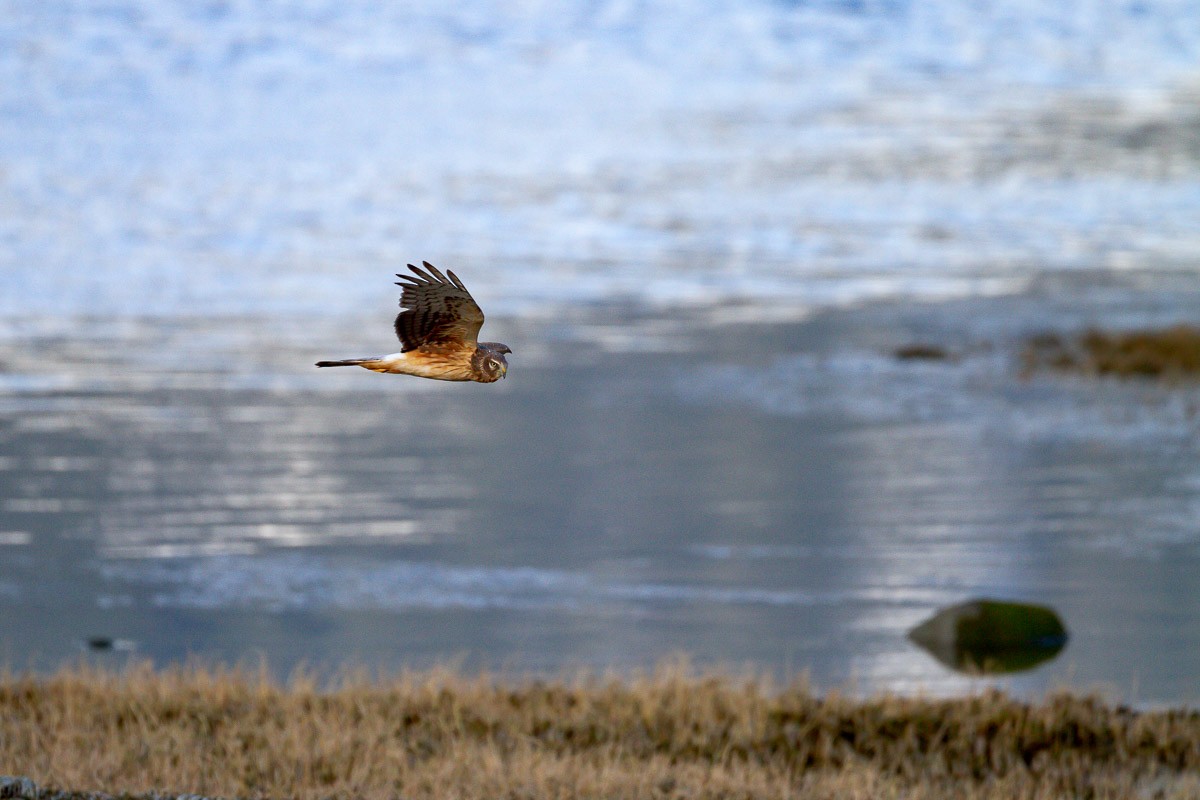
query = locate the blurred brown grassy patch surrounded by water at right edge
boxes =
[1021,325,1200,380]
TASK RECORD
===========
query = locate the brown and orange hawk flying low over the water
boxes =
[317,261,512,384]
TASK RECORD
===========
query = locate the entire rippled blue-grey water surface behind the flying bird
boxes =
[0,0,1200,704]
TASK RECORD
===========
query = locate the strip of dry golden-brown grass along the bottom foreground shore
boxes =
[0,663,1200,800]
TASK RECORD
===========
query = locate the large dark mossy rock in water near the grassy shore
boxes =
[908,599,1067,674]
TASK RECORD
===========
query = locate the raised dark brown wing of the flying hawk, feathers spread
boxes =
[396,261,484,353]
